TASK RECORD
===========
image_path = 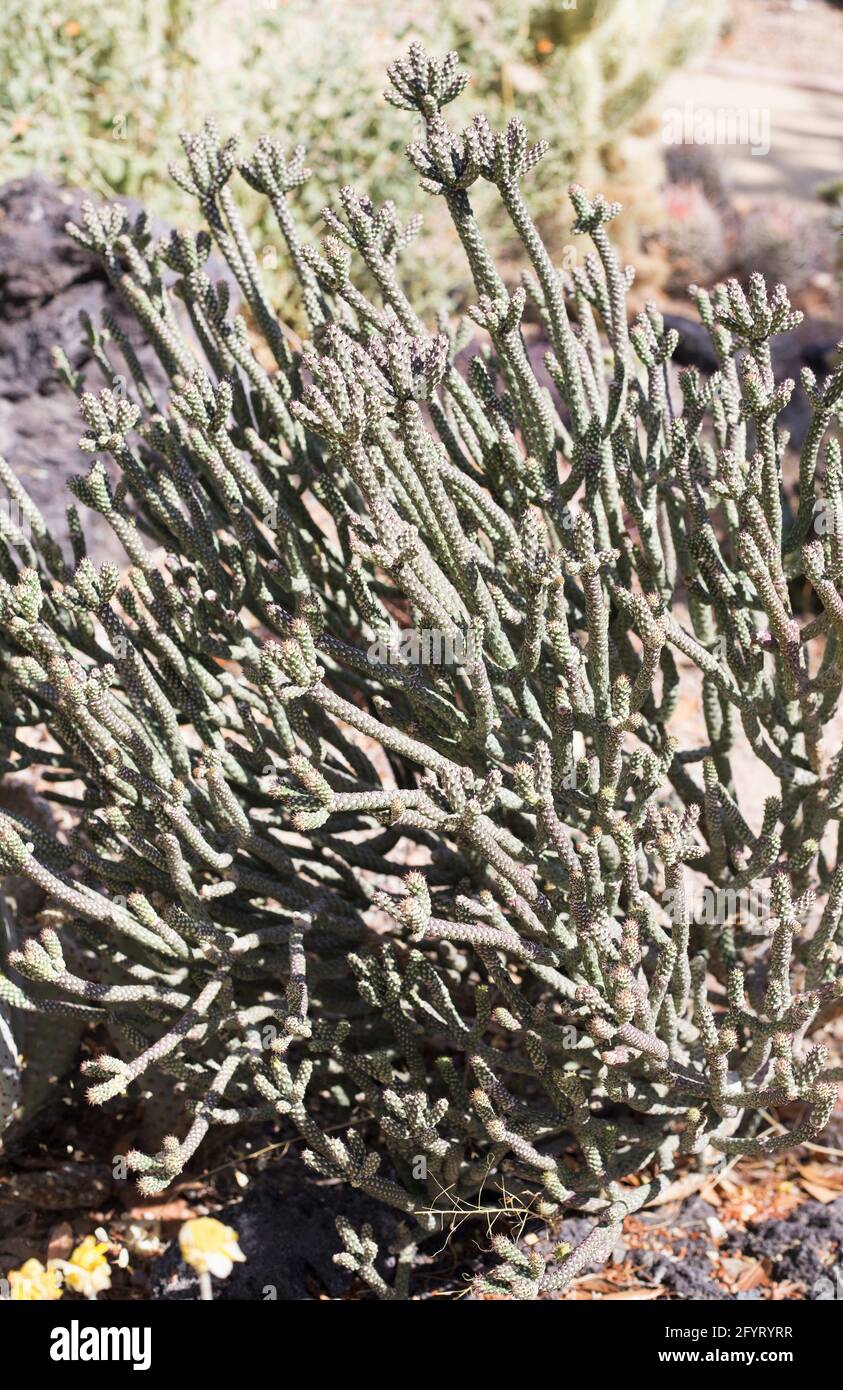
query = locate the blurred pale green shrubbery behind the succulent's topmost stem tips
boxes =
[0,0,723,318]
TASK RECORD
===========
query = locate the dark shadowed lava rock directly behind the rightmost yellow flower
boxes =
[152,1182,398,1301]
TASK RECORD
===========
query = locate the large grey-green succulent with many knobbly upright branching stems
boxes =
[0,44,843,1297]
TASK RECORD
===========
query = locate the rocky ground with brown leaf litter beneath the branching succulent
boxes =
[0,1080,843,1301]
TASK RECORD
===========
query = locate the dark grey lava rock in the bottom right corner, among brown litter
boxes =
[728,1197,843,1300]
